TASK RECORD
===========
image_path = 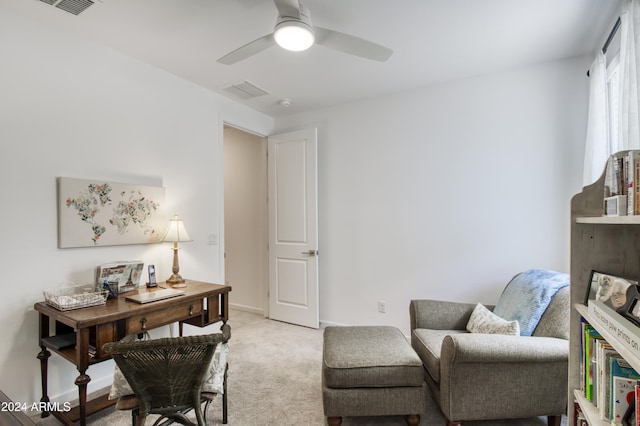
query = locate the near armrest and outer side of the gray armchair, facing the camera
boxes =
[440,333,569,419]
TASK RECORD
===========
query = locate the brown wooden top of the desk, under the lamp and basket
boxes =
[34,280,231,328]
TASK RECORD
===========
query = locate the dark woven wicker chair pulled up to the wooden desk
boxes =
[104,324,231,426]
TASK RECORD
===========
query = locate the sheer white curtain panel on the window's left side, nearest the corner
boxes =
[582,51,611,186]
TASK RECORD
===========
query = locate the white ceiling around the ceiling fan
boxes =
[0,0,620,117]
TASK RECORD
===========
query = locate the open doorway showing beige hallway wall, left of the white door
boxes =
[223,125,269,317]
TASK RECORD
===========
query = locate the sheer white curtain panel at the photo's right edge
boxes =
[613,0,640,152]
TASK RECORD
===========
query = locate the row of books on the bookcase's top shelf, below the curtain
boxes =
[604,150,640,216]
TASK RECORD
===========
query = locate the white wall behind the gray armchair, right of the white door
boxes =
[276,58,589,333]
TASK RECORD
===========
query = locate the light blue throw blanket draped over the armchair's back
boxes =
[493,269,569,336]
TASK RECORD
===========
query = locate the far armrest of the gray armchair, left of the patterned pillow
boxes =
[409,299,494,331]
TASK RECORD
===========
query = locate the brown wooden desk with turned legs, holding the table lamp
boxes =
[34,280,231,426]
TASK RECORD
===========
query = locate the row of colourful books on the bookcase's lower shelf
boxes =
[581,321,640,425]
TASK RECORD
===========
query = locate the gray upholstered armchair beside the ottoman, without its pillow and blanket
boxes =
[410,272,570,426]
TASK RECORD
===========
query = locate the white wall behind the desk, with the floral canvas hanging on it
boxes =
[0,7,273,404]
